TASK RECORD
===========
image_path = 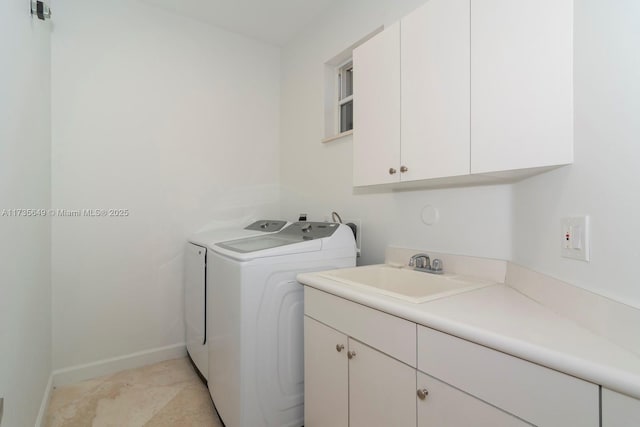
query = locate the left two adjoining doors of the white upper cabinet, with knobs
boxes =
[353,0,470,186]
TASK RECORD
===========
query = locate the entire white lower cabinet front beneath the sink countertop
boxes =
[304,287,600,427]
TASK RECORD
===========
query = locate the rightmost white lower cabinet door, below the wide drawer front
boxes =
[418,372,530,427]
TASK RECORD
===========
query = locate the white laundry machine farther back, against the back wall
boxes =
[184,220,288,381]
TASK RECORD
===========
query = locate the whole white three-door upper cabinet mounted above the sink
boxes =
[353,0,573,186]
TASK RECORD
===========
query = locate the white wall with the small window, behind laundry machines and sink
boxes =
[280,0,511,267]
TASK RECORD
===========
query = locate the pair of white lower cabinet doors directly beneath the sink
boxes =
[304,316,416,427]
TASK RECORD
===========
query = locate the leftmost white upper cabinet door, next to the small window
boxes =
[353,24,400,186]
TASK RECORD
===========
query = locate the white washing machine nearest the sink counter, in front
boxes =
[207,222,356,427]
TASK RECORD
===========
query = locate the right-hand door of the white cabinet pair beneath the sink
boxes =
[349,338,416,427]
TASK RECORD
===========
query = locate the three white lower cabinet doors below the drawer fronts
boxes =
[304,316,529,427]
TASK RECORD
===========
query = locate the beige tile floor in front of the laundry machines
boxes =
[45,358,222,427]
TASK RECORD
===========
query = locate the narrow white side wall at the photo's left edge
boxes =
[0,0,51,426]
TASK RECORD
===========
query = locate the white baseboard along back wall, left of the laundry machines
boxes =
[53,343,187,387]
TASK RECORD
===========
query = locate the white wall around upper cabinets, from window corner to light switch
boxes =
[281,0,640,307]
